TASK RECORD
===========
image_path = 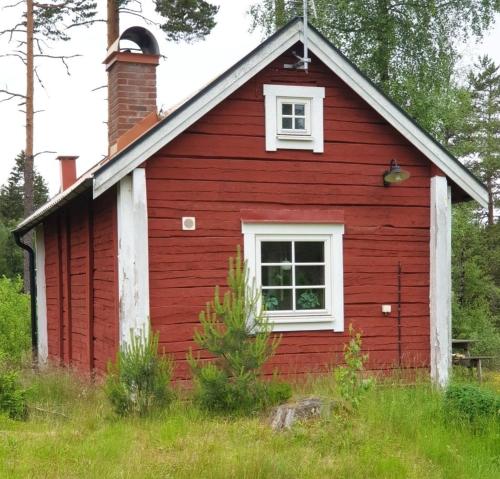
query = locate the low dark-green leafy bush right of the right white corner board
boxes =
[443,384,500,422]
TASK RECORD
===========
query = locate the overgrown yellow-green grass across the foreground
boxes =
[0,371,500,479]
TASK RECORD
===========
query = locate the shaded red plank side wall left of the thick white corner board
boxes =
[44,191,118,371]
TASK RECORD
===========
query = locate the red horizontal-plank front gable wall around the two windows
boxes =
[146,47,430,378]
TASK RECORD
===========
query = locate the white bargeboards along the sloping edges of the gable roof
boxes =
[16,18,488,235]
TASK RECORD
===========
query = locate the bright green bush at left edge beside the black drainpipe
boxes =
[0,277,31,364]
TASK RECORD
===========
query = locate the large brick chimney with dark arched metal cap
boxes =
[104,27,160,154]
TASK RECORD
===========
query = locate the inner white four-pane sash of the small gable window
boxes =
[277,98,311,136]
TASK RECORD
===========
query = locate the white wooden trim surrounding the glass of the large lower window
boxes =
[242,222,344,332]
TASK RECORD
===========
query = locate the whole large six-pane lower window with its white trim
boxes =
[243,223,344,331]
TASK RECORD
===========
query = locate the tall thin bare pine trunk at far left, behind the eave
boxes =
[24,0,34,292]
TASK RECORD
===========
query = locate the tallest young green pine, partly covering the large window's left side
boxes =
[188,249,290,413]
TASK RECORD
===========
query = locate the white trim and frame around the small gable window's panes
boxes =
[264,85,325,153]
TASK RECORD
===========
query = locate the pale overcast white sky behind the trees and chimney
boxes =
[0,0,500,195]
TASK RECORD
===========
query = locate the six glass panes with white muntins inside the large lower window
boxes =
[260,240,327,312]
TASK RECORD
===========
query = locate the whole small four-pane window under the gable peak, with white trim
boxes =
[264,85,325,153]
